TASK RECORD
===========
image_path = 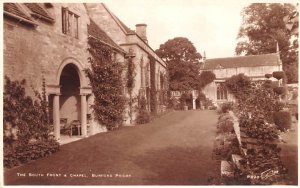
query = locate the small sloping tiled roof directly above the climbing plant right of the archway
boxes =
[88,19,124,52]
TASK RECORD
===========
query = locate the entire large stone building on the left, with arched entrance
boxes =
[3,3,165,142]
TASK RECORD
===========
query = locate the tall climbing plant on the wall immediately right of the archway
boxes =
[86,38,125,130]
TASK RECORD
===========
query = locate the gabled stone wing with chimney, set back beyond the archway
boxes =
[85,3,168,120]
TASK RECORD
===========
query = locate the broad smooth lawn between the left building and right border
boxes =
[4,110,220,185]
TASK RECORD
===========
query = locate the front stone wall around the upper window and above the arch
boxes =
[3,4,89,94]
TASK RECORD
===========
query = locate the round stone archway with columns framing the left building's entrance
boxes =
[47,58,92,140]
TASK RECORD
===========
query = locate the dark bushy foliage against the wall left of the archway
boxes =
[3,76,59,168]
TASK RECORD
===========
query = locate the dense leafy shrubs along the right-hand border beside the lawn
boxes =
[226,74,285,184]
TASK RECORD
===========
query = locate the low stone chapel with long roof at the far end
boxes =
[201,52,282,104]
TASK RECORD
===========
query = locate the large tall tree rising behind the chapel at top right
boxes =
[235,3,298,83]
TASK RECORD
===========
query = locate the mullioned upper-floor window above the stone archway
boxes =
[62,8,79,38]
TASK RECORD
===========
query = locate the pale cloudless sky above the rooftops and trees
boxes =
[101,0,250,58]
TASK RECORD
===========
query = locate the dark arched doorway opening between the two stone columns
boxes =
[59,64,81,135]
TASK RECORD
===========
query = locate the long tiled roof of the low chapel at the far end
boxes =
[203,53,280,69]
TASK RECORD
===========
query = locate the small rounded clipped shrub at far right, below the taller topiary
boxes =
[273,111,292,131]
